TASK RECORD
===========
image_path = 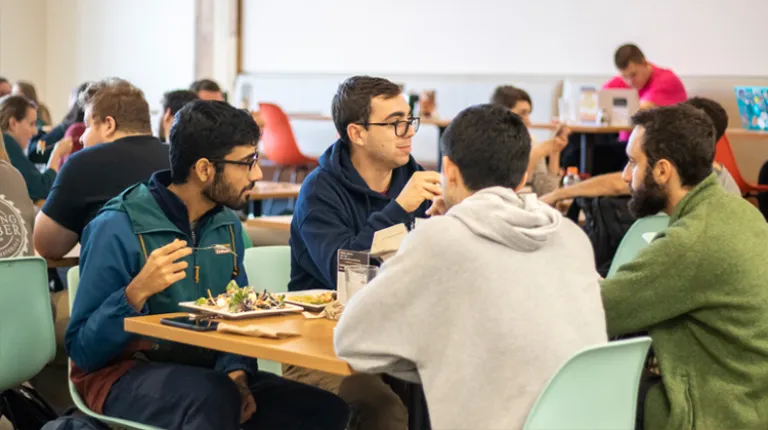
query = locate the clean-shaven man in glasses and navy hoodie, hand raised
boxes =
[288,76,441,291]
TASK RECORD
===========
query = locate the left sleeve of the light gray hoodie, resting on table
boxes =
[334,220,452,382]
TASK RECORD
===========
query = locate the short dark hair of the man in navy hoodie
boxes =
[331,76,402,143]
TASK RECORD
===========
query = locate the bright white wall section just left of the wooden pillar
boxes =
[44,0,195,125]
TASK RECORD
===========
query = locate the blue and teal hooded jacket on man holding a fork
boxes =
[65,171,258,380]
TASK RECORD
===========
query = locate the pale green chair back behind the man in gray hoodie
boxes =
[523,337,651,430]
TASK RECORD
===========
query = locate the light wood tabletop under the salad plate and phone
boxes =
[125,313,352,375]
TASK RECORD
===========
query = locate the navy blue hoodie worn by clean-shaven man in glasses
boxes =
[288,140,431,291]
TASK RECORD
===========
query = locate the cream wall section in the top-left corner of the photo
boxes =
[0,0,48,98]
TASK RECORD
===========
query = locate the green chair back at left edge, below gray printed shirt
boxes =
[0,257,56,392]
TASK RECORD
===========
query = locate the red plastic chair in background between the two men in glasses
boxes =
[259,103,317,183]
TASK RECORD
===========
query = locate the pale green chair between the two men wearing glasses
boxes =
[243,246,291,376]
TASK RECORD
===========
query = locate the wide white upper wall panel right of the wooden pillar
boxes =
[244,0,768,76]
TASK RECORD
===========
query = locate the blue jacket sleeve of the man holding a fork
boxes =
[65,211,148,372]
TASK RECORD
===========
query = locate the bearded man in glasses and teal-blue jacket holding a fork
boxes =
[66,100,347,430]
